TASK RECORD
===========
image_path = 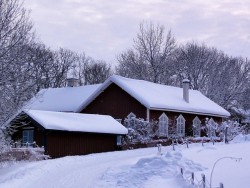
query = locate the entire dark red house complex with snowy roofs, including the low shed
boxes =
[11,75,230,157]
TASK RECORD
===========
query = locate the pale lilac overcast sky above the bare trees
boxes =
[25,0,250,63]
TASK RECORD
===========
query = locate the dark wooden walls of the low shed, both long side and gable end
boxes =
[12,117,117,158]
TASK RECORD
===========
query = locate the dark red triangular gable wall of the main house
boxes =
[81,84,147,119]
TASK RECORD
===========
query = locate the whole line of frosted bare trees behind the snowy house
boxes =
[0,0,250,129]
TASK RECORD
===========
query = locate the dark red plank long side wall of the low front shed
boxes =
[46,131,116,158]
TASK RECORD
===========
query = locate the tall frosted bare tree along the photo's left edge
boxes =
[0,0,34,124]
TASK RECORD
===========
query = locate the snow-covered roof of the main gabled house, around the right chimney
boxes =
[78,75,230,117]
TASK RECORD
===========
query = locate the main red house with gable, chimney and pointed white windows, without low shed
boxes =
[77,76,230,137]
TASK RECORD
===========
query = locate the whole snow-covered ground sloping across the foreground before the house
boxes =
[0,134,250,188]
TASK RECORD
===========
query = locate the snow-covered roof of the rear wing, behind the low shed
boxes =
[24,84,101,112]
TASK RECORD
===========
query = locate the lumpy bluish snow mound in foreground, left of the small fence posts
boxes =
[96,151,206,188]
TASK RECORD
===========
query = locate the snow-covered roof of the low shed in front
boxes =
[24,110,128,134]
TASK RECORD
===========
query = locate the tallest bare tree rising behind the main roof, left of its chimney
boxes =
[116,22,176,83]
